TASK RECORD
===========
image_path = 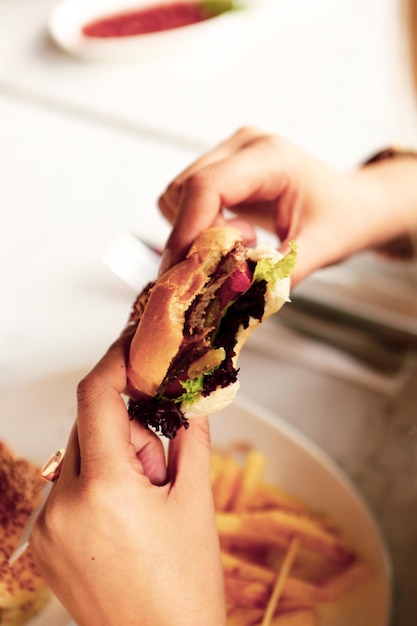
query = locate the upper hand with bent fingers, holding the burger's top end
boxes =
[159,128,415,286]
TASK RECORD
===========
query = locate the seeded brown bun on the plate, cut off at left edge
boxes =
[0,441,52,626]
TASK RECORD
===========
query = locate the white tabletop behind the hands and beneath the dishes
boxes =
[0,0,417,626]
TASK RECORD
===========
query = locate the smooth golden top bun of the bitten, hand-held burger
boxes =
[128,227,241,396]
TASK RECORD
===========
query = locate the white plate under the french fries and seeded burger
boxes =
[0,370,390,626]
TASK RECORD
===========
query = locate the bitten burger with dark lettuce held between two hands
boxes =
[128,227,296,438]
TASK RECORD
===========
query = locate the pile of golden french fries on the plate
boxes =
[212,446,372,626]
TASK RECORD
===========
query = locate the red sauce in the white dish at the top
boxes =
[82,2,227,37]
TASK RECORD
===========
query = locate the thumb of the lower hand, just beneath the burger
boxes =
[168,417,211,492]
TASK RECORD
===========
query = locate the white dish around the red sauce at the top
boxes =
[48,0,260,61]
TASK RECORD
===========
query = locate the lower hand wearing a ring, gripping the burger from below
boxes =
[31,340,225,626]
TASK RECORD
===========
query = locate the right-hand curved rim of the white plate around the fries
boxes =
[210,396,391,626]
